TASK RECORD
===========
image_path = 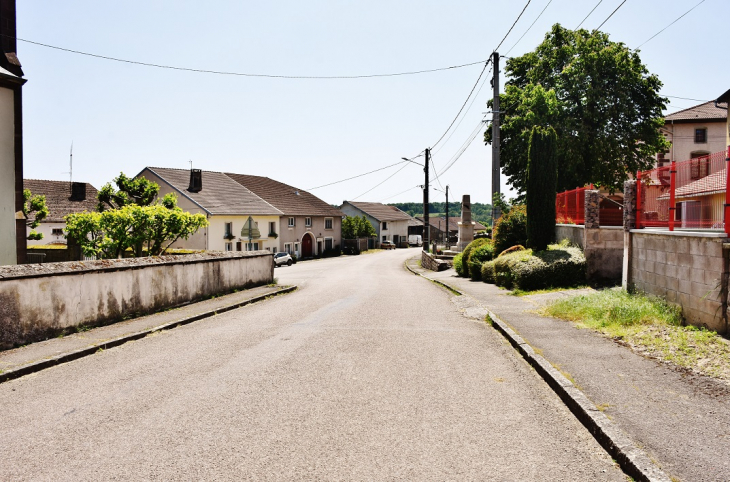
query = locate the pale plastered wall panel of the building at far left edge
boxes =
[0,87,18,265]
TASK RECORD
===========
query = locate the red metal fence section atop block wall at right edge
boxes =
[636,147,730,232]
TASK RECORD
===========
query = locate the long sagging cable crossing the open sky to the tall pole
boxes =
[5,34,486,80]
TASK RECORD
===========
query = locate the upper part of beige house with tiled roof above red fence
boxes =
[657,101,728,167]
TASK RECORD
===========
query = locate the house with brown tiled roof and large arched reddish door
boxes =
[226,173,344,258]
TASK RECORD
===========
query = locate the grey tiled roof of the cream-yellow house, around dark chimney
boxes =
[142,167,283,216]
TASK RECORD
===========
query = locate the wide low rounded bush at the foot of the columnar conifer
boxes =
[494,245,586,291]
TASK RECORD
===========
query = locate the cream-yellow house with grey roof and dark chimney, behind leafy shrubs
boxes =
[137,167,283,252]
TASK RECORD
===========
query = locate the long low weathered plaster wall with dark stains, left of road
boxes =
[0,251,274,348]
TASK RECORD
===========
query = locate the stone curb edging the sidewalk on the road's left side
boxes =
[0,286,297,383]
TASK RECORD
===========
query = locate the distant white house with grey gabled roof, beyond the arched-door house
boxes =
[340,201,413,247]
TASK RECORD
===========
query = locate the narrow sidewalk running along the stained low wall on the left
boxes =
[0,286,296,383]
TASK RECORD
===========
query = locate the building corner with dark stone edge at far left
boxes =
[0,0,26,265]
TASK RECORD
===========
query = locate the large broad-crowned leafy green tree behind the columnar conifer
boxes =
[484,24,668,194]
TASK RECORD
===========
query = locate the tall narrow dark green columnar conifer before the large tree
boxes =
[526,126,558,251]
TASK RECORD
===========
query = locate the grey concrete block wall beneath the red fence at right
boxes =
[628,229,728,333]
